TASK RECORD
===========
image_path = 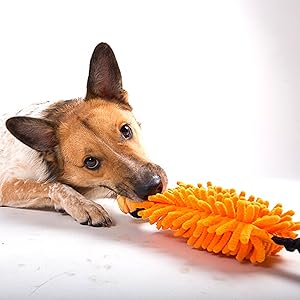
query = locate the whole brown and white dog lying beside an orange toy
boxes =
[0,43,167,226]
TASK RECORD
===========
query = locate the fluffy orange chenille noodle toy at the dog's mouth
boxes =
[118,182,300,263]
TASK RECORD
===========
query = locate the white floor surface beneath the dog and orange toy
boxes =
[0,179,300,300]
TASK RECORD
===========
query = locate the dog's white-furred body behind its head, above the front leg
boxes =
[0,102,49,184]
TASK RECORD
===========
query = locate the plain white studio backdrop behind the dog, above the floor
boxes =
[0,0,300,182]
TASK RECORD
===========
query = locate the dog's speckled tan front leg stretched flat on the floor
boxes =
[0,179,112,226]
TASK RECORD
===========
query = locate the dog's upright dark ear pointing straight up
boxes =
[85,43,127,104]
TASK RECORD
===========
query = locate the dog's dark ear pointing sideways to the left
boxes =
[6,117,58,152]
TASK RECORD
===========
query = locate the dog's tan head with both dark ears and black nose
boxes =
[6,43,167,201]
